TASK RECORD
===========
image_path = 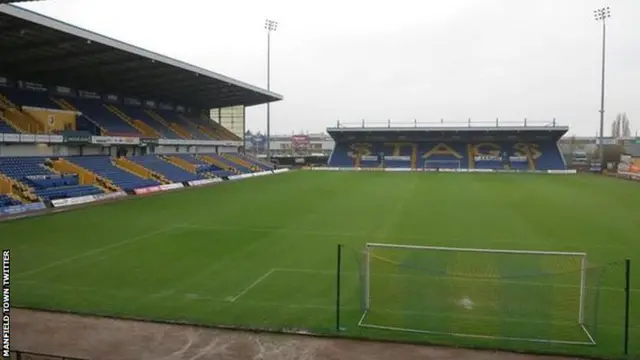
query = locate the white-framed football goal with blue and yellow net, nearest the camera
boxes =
[358,243,603,345]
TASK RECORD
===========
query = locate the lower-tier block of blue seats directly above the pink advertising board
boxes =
[66,156,160,191]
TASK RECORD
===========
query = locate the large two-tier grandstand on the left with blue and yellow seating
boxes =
[0,5,282,214]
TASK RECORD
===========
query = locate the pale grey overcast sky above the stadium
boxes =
[23,0,640,135]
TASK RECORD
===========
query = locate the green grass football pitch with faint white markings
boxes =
[0,171,640,355]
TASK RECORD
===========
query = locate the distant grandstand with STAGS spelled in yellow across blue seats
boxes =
[327,120,568,171]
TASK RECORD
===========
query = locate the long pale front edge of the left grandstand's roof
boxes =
[0,4,284,101]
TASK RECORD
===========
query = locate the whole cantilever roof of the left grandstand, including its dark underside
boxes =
[0,5,282,108]
